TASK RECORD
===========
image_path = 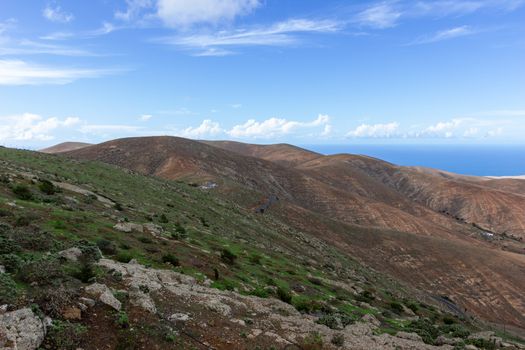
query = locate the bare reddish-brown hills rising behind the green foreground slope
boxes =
[67,137,525,328]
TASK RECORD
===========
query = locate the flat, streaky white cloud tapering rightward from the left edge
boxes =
[0,60,122,85]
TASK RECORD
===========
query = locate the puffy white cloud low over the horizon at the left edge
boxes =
[0,113,80,143]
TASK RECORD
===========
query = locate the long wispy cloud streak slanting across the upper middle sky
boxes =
[156,19,341,55]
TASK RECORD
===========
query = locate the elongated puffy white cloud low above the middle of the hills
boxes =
[227,114,330,138]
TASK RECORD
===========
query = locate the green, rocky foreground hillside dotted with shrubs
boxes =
[0,148,519,349]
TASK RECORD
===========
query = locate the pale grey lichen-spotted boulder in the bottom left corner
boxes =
[0,308,46,350]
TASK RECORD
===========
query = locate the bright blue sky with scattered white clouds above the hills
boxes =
[0,0,525,148]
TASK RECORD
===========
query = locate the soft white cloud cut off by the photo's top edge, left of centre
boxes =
[157,0,260,27]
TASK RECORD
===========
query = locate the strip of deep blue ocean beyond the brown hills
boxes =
[302,145,525,176]
